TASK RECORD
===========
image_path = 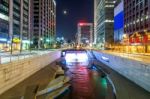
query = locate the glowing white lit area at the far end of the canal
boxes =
[65,53,88,64]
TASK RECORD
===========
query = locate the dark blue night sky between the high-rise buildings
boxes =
[56,0,94,40]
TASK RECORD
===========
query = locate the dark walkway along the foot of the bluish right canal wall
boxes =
[94,61,150,99]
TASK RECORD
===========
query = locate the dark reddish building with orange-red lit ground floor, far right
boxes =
[124,0,150,52]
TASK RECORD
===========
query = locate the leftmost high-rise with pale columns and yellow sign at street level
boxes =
[0,0,30,50]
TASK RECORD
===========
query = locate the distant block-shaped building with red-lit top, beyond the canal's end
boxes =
[77,23,94,46]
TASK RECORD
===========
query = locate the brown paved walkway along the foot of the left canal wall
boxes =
[0,63,58,99]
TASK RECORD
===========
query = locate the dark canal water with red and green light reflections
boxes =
[57,55,113,99]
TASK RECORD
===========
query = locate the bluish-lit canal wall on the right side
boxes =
[93,51,150,92]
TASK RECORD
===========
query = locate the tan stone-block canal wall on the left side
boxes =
[0,51,60,94]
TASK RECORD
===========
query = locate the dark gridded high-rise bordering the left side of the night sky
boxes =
[32,0,56,49]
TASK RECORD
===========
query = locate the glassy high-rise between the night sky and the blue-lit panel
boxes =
[94,0,116,48]
